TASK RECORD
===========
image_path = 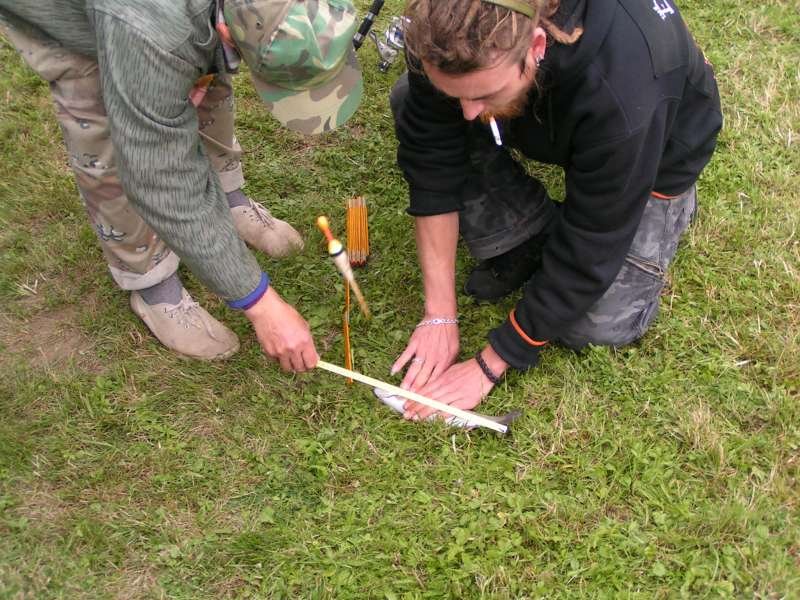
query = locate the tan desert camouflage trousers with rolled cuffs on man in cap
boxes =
[0,21,244,290]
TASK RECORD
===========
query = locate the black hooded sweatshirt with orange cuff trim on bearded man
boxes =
[396,0,722,369]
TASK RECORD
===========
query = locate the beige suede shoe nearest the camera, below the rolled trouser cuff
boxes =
[131,290,239,360]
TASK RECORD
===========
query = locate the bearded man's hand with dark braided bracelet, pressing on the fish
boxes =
[403,346,508,421]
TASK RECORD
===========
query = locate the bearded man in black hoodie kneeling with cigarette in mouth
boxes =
[391,0,722,419]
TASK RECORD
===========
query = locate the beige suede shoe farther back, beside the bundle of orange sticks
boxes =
[231,198,303,258]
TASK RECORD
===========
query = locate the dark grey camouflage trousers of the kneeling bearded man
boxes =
[390,75,697,349]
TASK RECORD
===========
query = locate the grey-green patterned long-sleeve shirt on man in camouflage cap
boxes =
[0,0,261,300]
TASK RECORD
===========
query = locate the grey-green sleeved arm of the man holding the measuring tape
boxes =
[96,15,261,300]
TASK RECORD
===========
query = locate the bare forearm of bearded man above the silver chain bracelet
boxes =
[416,212,458,317]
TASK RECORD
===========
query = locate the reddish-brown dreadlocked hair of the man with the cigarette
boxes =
[404,0,583,74]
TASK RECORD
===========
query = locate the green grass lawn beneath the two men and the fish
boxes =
[0,0,800,598]
